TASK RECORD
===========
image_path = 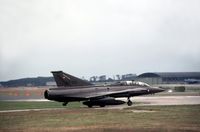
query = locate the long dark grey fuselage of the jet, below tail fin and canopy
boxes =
[45,86,163,102]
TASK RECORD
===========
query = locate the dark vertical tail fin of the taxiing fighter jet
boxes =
[51,71,92,87]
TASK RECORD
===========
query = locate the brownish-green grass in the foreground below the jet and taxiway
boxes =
[0,102,200,132]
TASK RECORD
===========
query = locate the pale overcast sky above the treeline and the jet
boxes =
[0,0,200,81]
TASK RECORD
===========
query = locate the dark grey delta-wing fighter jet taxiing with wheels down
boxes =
[44,71,164,108]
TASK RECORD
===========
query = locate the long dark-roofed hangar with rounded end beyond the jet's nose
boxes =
[136,72,200,84]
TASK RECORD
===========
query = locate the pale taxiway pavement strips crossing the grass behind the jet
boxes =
[0,96,200,113]
